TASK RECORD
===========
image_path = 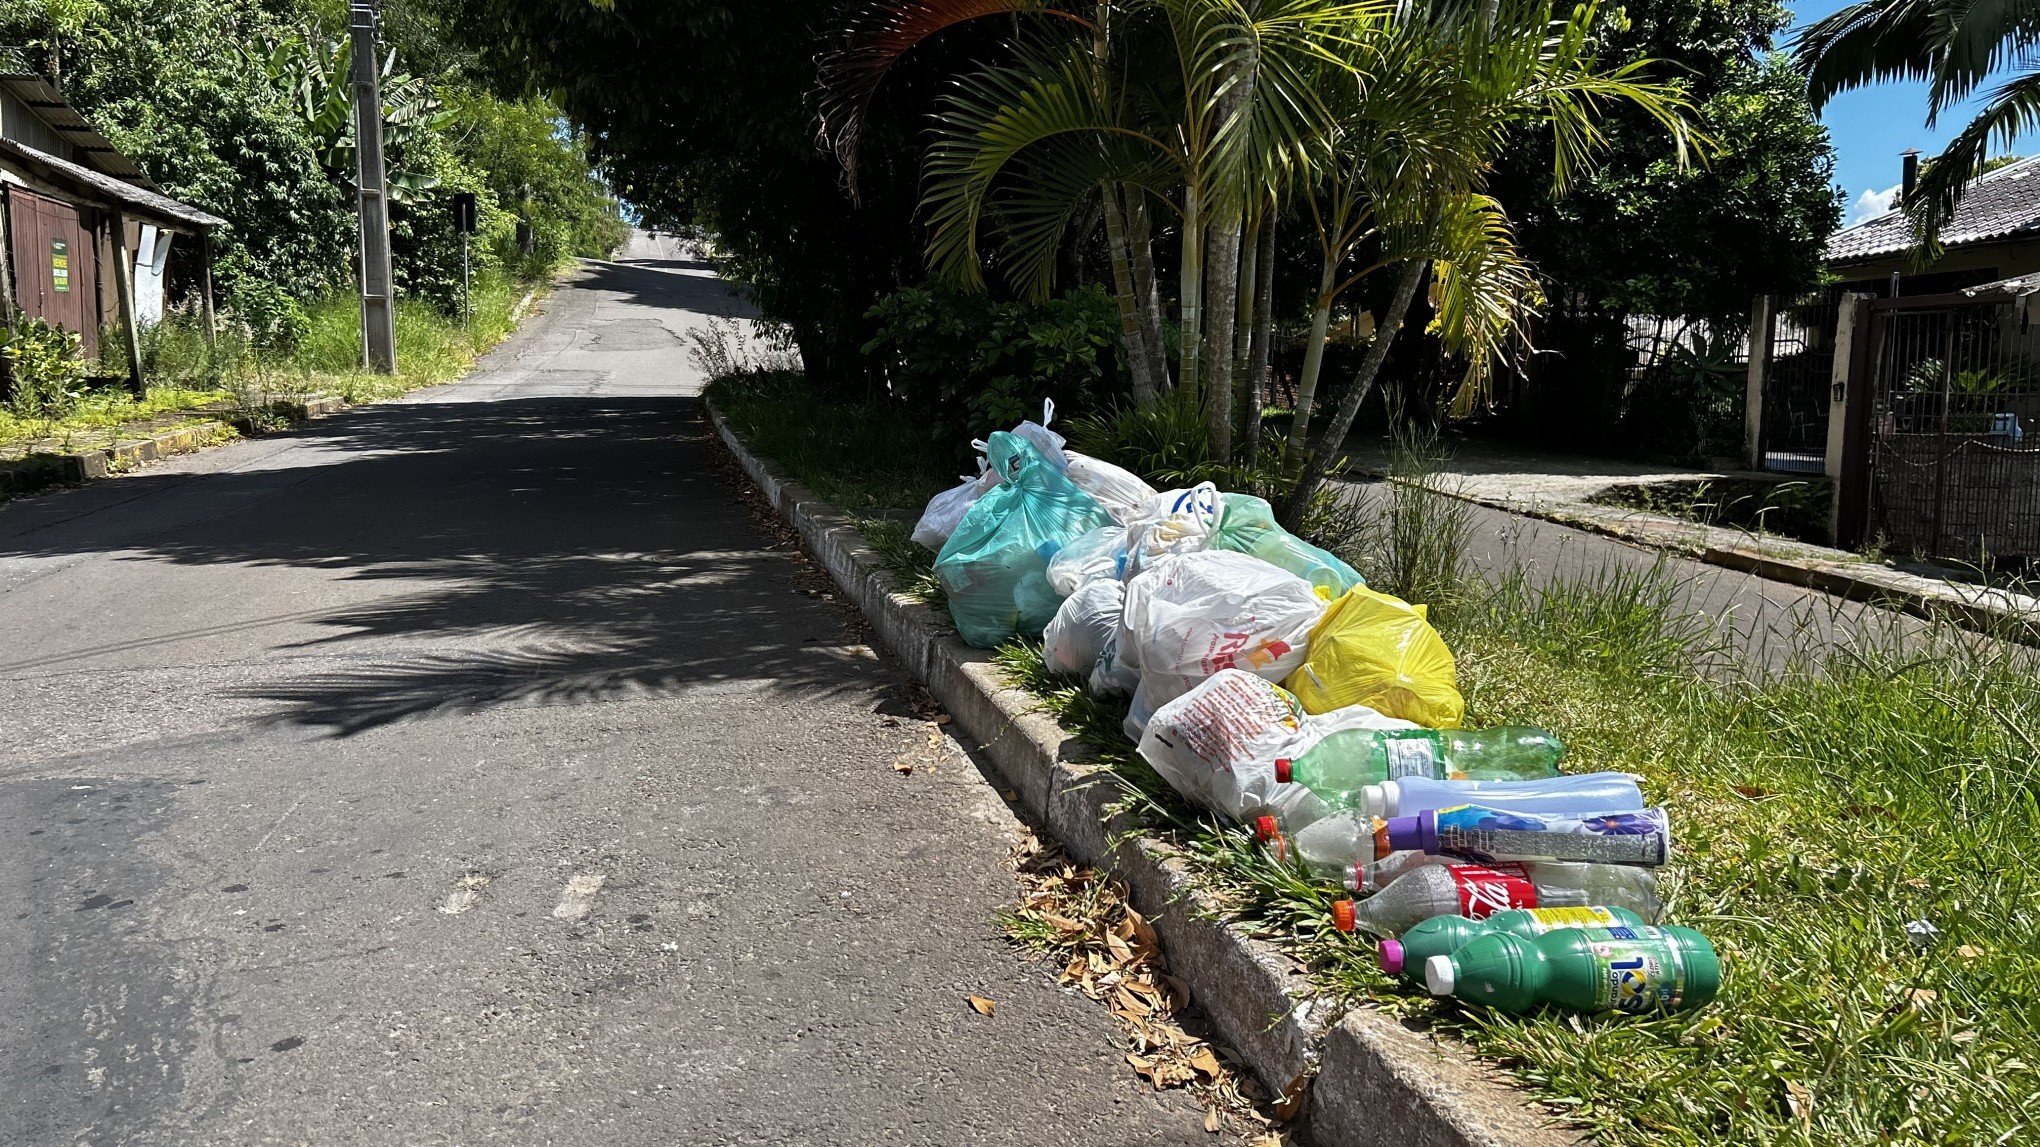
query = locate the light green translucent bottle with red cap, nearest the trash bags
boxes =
[1275,725,1565,808]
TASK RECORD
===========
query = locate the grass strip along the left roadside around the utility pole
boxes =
[0,276,532,451]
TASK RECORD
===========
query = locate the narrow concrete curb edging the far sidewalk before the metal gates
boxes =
[1346,471,2040,645]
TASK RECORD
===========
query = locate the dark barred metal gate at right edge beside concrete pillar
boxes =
[1858,292,2040,563]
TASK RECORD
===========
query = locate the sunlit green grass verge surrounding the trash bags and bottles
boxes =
[705,373,2040,1147]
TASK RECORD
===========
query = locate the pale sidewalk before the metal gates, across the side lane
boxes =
[1348,439,2040,637]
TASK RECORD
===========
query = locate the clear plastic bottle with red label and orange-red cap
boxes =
[1353,863,1659,937]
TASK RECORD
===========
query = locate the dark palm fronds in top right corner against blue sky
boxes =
[1793,0,2040,247]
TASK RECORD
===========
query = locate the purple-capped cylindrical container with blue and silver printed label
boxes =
[1375,804,1671,865]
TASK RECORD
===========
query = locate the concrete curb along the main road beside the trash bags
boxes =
[708,406,1579,1147]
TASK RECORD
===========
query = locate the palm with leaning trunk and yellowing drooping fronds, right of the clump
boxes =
[1281,0,1691,529]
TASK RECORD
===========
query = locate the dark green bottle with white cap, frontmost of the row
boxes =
[1424,925,1722,1014]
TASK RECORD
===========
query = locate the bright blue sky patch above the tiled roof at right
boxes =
[1791,0,2040,222]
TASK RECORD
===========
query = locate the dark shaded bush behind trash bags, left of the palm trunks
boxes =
[865,286,1124,441]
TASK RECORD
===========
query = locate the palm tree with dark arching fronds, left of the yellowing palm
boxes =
[824,0,1385,459]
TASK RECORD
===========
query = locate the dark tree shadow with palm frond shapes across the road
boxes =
[0,398,873,735]
